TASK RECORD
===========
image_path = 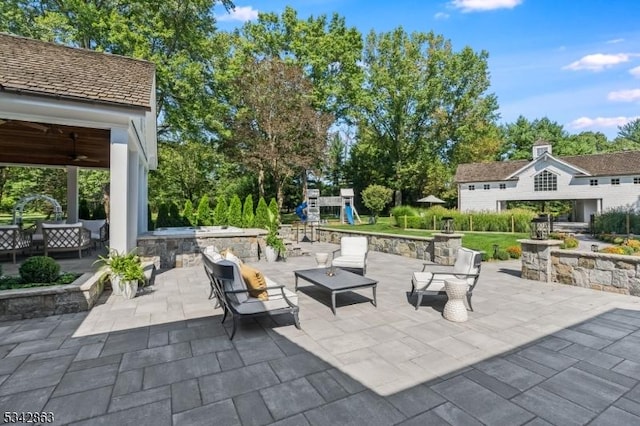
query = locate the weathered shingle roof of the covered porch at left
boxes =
[0,33,155,109]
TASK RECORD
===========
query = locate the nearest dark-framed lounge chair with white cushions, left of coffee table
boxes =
[202,253,300,339]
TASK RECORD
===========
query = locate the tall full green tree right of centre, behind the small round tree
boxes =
[352,28,498,204]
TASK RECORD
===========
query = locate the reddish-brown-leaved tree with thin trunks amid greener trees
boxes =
[228,58,333,208]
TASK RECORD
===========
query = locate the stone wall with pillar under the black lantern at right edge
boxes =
[521,240,640,296]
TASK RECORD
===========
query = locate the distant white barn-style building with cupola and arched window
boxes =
[455,141,640,222]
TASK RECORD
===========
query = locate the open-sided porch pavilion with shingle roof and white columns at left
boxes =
[0,33,158,251]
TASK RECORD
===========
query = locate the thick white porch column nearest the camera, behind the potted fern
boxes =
[109,128,132,252]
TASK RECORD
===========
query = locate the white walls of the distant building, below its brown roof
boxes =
[459,159,640,213]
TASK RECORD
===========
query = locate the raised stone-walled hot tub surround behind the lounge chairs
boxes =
[138,226,267,269]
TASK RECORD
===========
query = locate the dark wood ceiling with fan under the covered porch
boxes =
[0,117,111,169]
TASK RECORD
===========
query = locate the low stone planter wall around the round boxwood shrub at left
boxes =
[0,272,104,321]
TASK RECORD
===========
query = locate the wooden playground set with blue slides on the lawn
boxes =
[296,188,362,225]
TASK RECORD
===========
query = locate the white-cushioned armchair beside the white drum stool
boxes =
[411,248,482,311]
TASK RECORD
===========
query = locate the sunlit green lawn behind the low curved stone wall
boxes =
[327,218,529,257]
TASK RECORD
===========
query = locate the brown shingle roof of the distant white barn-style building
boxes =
[455,151,640,183]
